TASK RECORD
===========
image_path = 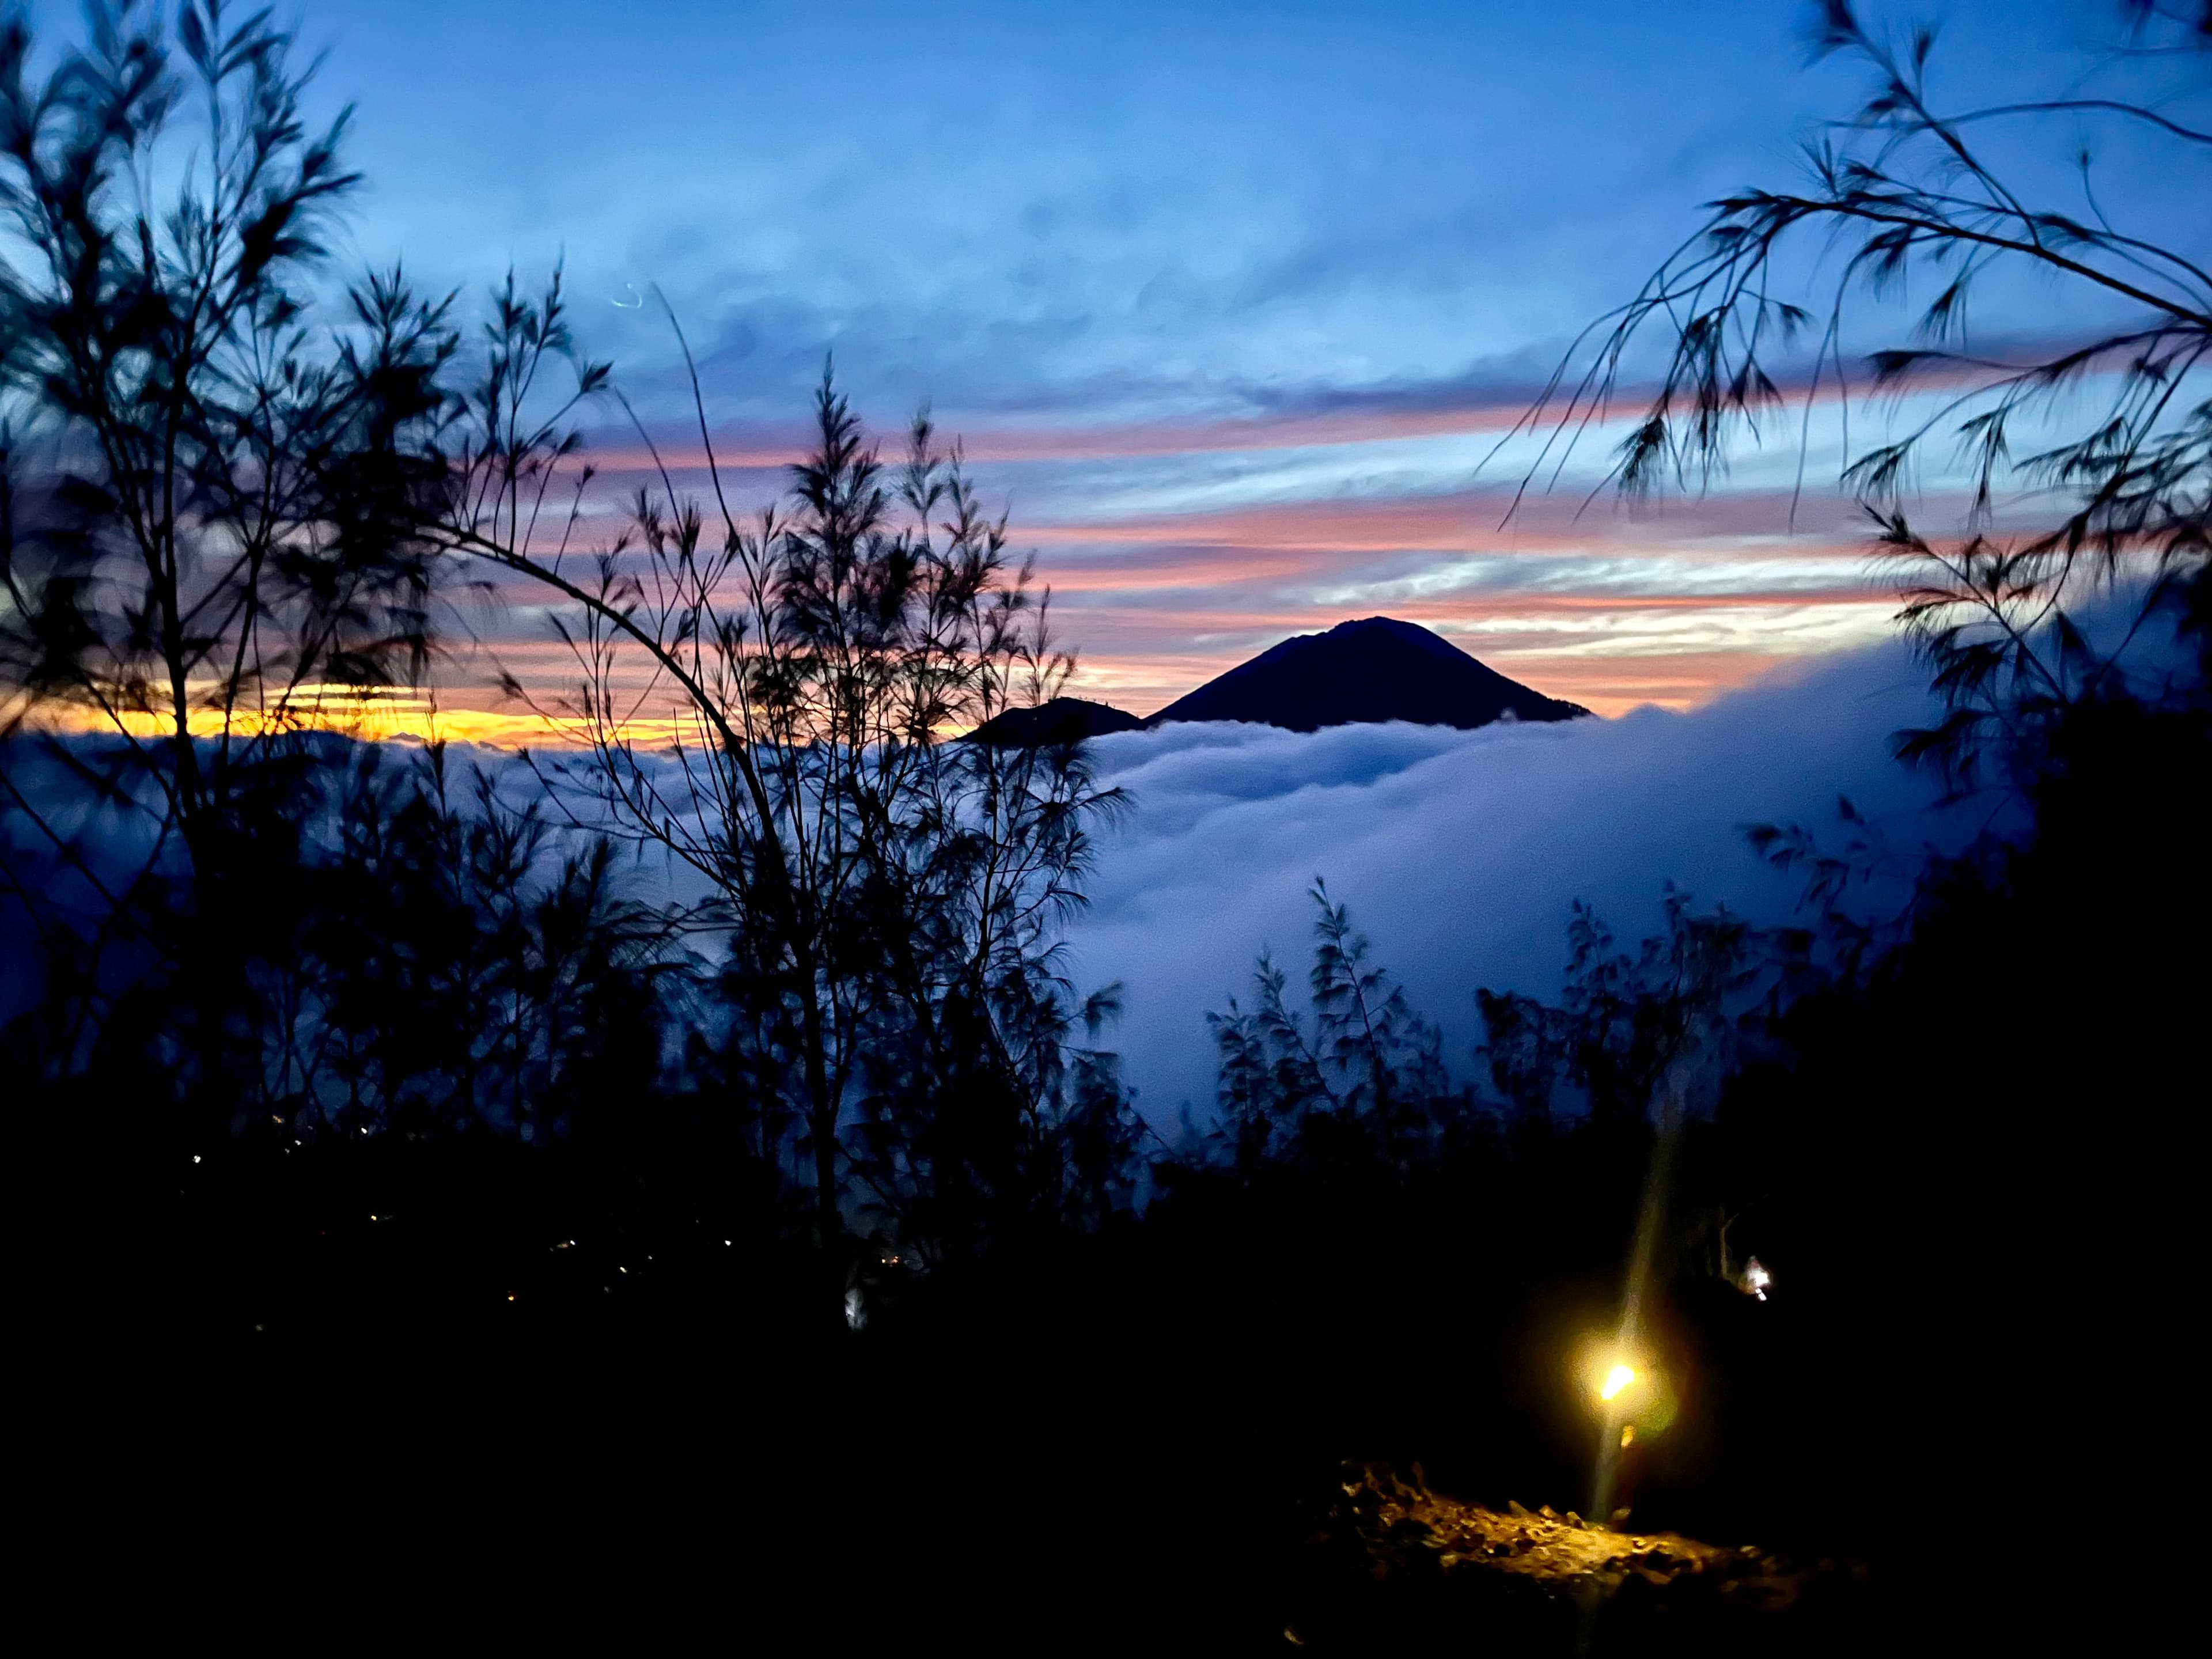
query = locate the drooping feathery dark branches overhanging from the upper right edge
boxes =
[1517,0,2212,787]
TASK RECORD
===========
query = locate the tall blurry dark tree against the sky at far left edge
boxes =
[0,0,451,1115]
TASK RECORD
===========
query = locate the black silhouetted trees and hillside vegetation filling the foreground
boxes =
[0,7,2212,1652]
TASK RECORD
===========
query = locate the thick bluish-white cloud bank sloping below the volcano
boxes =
[1071,646,1938,1132]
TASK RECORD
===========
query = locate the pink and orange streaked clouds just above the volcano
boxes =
[440,442,1893,714]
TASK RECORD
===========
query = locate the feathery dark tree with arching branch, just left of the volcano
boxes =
[420,283,1128,1254]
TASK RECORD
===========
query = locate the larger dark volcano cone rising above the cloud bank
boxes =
[1146,617,1590,732]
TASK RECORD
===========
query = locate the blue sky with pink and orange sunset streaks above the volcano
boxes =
[33,0,2205,734]
